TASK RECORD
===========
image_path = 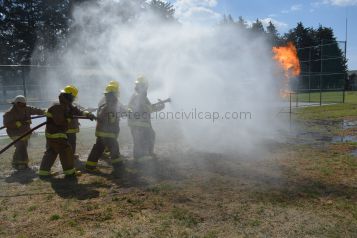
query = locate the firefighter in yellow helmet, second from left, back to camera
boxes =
[38,85,95,178]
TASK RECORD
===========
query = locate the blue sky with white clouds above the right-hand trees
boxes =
[169,0,357,70]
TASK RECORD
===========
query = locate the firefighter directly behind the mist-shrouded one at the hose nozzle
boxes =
[86,84,126,174]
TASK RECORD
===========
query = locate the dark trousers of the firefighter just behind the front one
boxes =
[86,137,120,167]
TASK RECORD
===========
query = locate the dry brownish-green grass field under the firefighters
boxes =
[0,94,357,238]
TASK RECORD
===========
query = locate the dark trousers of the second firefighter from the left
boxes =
[40,138,74,171]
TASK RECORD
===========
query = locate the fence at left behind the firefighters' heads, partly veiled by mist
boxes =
[0,65,117,111]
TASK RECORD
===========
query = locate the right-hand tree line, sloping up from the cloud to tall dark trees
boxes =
[221,15,351,90]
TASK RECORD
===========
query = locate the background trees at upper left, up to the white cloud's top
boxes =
[0,0,175,65]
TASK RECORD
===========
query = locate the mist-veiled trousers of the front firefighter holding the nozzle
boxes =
[130,126,155,159]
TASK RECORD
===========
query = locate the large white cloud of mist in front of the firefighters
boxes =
[42,0,281,152]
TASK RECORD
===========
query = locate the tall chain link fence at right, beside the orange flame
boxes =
[289,41,348,107]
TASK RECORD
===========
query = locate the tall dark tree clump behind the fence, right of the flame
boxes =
[284,22,347,89]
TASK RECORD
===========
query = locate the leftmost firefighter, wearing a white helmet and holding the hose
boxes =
[3,95,45,170]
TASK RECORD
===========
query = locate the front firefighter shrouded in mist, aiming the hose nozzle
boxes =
[128,76,165,160]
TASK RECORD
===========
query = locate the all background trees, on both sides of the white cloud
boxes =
[0,0,347,89]
